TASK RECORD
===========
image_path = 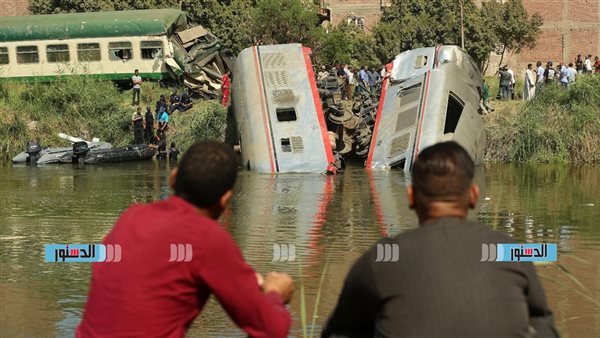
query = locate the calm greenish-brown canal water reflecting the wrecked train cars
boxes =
[0,162,600,338]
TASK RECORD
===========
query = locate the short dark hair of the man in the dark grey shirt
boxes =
[412,141,475,201]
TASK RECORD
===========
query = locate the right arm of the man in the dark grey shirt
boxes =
[523,263,559,338]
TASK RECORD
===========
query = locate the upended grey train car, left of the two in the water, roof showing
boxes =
[232,44,334,173]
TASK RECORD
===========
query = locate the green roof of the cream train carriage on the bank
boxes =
[0,9,187,42]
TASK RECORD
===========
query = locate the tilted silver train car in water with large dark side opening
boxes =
[366,46,485,171]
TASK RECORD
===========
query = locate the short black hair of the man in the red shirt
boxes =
[173,142,237,208]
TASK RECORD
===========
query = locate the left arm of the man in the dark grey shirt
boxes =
[321,249,379,338]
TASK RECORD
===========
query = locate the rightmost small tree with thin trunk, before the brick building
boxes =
[481,0,543,65]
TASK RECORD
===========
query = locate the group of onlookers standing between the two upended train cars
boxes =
[317,64,386,100]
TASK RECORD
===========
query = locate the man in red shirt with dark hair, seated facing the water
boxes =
[76,143,293,337]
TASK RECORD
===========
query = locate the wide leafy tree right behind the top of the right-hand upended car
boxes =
[373,0,495,69]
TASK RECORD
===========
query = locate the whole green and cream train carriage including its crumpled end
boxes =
[0,9,232,97]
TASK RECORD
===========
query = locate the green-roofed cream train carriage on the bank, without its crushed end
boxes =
[0,9,187,80]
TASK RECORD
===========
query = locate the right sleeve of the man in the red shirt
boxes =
[200,230,292,338]
